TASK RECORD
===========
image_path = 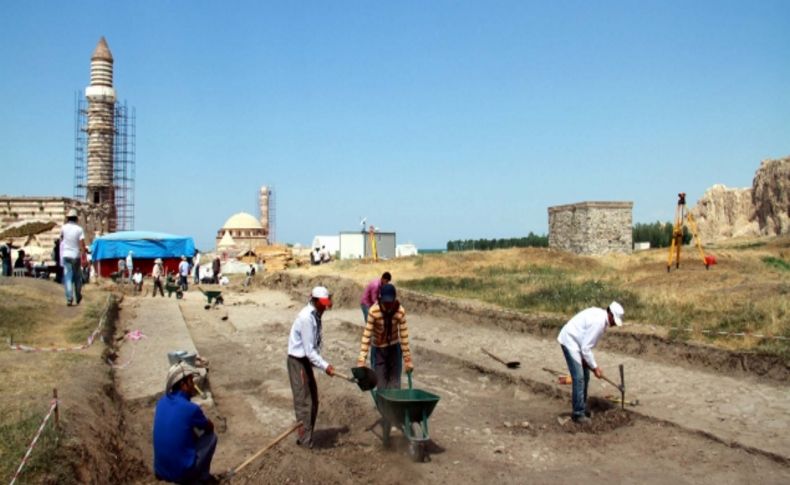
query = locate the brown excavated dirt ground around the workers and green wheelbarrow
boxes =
[114,288,790,484]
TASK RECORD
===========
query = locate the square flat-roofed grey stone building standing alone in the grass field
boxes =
[549,202,634,254]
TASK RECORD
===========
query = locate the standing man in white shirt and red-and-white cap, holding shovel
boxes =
[286,286,335,448]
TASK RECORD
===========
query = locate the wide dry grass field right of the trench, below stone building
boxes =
[297,237,790,355]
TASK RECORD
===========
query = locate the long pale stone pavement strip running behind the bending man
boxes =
[324,304,790,460]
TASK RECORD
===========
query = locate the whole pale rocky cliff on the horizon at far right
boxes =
[691,158,790,242]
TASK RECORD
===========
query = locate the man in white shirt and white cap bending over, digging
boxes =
[557,301,625,424]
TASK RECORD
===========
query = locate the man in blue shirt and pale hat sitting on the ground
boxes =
[154,362,217,484]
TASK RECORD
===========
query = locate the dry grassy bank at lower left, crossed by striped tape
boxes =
[0,278,105,483]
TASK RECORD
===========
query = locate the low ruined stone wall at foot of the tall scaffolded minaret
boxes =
[0,196,115,254]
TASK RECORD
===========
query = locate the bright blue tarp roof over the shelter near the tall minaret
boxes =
[91,231,195,261]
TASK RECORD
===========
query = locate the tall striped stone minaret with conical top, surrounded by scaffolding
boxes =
[85,37,117,232]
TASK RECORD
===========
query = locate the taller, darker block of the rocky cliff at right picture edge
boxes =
[752,157,790,236]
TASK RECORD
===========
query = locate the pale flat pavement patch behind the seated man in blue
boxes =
[115,296,196,402]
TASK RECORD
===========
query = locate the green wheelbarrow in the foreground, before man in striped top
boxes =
[371,372,439,462]
